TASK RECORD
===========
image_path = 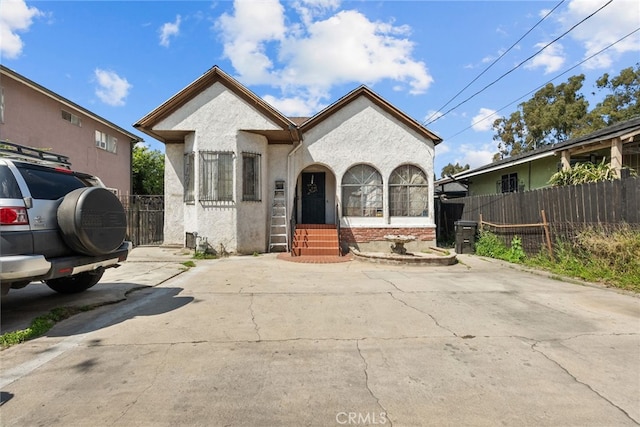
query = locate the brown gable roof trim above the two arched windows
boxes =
[300,86,442,145]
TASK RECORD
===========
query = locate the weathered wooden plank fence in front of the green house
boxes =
[442,177,640,253]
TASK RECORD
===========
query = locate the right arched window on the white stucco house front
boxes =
[389,165,429,216]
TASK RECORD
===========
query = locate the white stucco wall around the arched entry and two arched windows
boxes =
[291,97,435,231]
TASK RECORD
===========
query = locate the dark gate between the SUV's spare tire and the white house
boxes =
[120,196,164,246]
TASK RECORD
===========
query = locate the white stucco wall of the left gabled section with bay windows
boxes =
[159,83,286,253]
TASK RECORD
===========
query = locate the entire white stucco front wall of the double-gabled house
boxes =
[154,83,435,253]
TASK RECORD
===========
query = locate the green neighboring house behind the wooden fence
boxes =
[450,117,640,196]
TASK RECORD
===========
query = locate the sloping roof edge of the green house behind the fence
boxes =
[454,116,640,179]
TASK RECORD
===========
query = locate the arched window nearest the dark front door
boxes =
[342,165,382,216]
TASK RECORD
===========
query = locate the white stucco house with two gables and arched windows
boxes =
[134,67,441,253]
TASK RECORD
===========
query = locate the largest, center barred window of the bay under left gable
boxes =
[199,151,233,202]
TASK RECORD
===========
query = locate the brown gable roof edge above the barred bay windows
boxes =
[133,65,295,143]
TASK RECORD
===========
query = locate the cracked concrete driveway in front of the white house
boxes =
[0,249,640,426]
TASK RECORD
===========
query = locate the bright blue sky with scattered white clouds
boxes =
[0,0,640,177]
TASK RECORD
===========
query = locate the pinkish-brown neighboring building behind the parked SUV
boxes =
[0,65,142,195]
